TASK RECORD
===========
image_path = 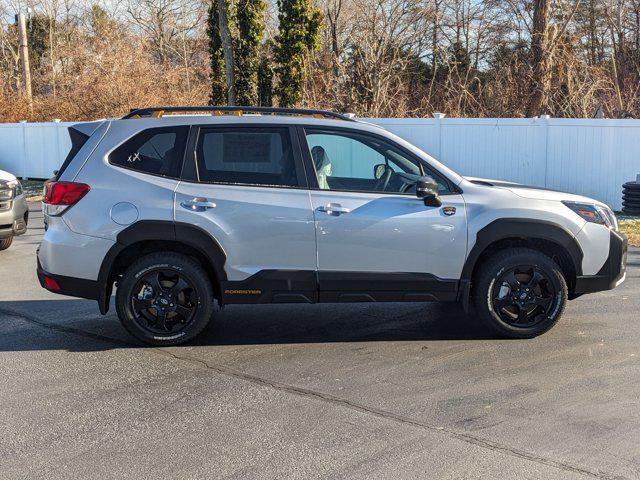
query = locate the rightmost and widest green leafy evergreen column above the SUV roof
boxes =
[274,0,322,107]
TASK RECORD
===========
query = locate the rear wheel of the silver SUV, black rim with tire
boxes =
[116,252,217,346]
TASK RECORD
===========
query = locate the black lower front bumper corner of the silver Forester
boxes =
[573,230,628,296]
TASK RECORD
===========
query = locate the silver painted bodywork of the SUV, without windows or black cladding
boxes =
[40,115,609,280]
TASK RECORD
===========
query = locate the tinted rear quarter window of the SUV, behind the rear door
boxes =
[109,126,189,178]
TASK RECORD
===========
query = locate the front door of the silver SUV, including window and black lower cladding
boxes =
[303,128,467,301]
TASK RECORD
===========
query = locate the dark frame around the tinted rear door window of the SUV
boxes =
[181,123,308,190]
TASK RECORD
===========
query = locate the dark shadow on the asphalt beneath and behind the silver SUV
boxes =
[0,300,495,351]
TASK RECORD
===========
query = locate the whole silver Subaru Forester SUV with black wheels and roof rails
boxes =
[38,107,627,345]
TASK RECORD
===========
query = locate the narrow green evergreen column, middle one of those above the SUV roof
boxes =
[234,0,267,106]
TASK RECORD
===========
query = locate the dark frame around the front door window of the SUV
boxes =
[297,125,462,197]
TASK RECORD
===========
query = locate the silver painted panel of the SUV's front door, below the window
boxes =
[311,190,467,279]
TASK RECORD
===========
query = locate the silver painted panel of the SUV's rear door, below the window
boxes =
[175,182,316,280]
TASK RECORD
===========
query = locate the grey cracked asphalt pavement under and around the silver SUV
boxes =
[0,203,640,479]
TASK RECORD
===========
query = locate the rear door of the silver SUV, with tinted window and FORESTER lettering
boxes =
[175,125,317,303]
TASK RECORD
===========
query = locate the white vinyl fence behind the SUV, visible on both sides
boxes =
[0,116,640,210]
